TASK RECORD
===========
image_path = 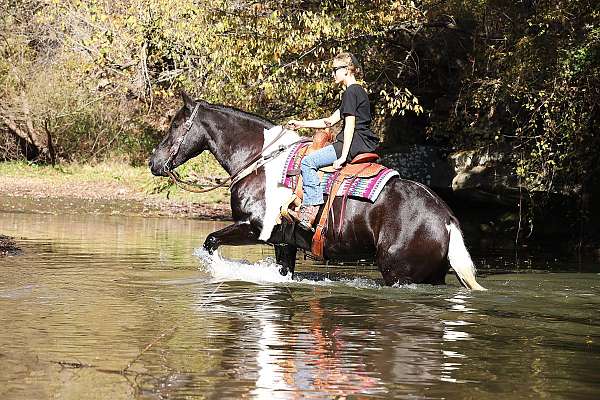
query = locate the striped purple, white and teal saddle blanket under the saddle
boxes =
[279,143,400,202]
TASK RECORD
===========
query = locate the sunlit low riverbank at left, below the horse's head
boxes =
[0,162,231,220]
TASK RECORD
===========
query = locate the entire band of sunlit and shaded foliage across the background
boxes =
[0,0,600,203]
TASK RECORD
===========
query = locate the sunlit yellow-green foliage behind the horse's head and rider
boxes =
[0,0,425,163]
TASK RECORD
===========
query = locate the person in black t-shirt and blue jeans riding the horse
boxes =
[288,53,379,229]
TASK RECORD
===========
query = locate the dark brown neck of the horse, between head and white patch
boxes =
[208,112,266,175]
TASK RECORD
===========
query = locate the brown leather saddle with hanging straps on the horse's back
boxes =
[281,129,385,258]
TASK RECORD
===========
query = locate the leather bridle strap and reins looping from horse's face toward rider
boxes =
[163,103,307,193]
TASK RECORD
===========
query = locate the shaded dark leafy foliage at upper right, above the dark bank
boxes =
[442,0,600,191]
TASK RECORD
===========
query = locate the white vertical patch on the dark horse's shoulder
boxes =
[258,126,300,242]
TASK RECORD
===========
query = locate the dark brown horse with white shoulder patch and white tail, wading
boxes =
[149,93,486,290]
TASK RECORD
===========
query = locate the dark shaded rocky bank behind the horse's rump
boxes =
[382,144,600,257]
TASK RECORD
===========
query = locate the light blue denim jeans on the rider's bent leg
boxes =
[300,145,337,206]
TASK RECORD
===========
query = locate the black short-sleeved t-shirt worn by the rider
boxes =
[333,84,379,161]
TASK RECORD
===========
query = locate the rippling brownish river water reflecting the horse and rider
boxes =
[0,207,600,399]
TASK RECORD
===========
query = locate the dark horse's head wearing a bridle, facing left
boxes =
[148,93,207,176]
